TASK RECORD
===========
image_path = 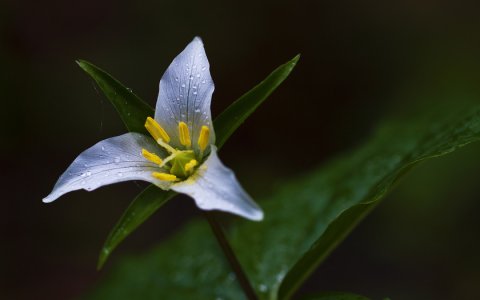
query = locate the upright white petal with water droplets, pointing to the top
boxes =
[155,37,215,150]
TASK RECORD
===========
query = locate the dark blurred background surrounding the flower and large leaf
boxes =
[0,0,480,299]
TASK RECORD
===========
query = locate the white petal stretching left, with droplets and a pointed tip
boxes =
[43,133,166,202]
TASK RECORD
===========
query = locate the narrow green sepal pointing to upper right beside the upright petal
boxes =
[214,54,300,148]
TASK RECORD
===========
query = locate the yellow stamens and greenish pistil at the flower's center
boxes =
[142,117,210,181]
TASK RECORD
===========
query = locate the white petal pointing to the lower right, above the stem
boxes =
[171,145,263,221]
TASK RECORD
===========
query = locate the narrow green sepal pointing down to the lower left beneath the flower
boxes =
[97,185,176,270]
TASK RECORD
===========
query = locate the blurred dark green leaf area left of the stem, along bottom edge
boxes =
[86,221,245,300]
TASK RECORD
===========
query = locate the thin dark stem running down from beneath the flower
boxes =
[204,211,258,300]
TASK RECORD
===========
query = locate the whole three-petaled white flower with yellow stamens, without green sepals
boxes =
[43,37,263,220]
